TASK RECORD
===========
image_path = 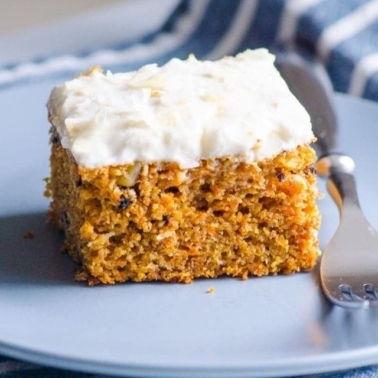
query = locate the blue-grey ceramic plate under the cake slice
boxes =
[0,82,378,378]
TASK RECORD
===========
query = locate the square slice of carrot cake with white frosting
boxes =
[48,49,320,284]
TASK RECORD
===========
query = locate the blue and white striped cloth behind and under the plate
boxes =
[0,0,378,378]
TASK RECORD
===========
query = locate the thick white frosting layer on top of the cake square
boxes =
[48,49,313,168]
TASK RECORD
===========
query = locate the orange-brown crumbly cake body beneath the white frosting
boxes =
[48,131,320,284]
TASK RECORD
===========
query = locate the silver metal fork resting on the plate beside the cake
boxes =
[276,52,378,308]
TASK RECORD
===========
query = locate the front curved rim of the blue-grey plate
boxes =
[0,341,378,378]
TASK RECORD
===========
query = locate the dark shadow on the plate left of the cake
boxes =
[0,212,77,285]
